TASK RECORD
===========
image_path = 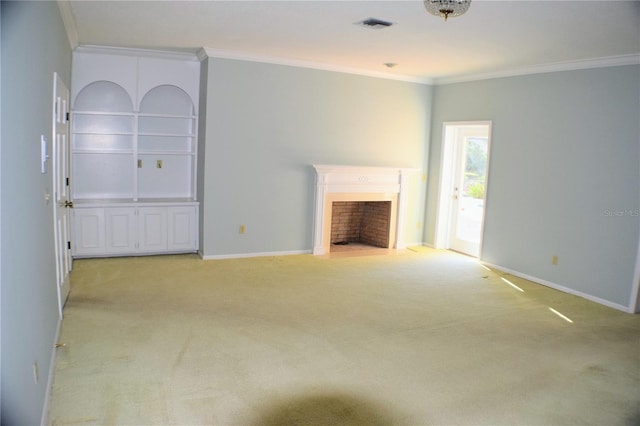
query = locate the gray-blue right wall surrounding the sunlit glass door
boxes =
[425,66,640,307]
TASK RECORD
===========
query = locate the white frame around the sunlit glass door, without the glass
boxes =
[434,120,493,259]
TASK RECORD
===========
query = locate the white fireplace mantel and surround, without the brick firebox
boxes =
[313,165,417,254]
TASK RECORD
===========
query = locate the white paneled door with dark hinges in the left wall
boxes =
[52,73,73,318]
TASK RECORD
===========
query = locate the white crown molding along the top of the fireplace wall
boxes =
[198,47,433,84]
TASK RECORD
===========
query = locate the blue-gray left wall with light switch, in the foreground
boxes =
[0,1,71,425]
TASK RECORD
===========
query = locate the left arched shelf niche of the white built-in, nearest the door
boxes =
[71,81,136,200]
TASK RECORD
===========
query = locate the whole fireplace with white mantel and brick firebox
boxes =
[313,165,412,254]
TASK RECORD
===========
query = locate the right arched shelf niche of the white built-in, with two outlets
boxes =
[137,84,197,199]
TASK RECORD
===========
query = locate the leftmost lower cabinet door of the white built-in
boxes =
[71,208,106,256]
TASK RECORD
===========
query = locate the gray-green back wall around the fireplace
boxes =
[201,58,431,256]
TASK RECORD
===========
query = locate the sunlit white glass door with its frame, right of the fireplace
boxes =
[435,122,491,257]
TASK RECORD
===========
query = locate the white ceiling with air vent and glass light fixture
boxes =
[62,0,640,82]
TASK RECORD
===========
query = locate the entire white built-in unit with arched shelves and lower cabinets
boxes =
[71,48,200,257]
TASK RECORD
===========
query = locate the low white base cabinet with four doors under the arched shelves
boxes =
[72,203,198,257]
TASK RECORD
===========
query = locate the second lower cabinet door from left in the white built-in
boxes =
[105,207,137,253]
